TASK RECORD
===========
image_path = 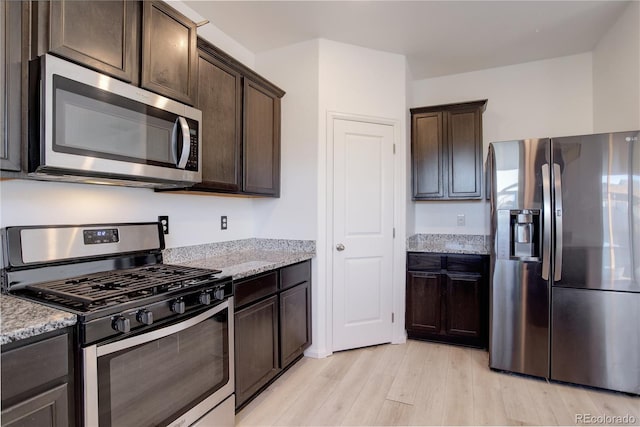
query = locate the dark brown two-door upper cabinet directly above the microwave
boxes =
[32,0,198,105]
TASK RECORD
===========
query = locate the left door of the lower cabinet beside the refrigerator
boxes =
[405,272,442,336]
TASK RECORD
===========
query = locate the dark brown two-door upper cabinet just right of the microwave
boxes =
[175,39,284,197]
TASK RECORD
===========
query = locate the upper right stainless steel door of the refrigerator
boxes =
[551,131,640,292]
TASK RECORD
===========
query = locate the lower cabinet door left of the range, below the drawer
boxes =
[2,384,70,427]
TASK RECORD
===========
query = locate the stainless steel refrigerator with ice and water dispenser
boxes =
[487,131,640,394]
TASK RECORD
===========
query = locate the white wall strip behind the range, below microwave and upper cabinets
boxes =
[0,180,254,247]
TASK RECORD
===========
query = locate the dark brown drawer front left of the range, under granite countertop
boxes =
[2,334,69,401]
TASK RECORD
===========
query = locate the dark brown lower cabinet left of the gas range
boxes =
[1,330,75,427]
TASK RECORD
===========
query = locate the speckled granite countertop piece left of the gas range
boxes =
[0,295,77,344]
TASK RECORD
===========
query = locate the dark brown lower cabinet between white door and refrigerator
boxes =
[405,253,489,348]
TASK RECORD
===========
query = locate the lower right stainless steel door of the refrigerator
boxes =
[551,287,640,394]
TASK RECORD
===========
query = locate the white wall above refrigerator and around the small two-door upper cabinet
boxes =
[410,53,593,234]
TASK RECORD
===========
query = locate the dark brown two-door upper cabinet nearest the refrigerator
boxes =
[411,99,487,200]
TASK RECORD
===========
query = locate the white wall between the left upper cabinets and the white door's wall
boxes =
[254,40,319,240]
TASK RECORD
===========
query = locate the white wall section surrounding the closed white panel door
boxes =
[313,39,407,356]
